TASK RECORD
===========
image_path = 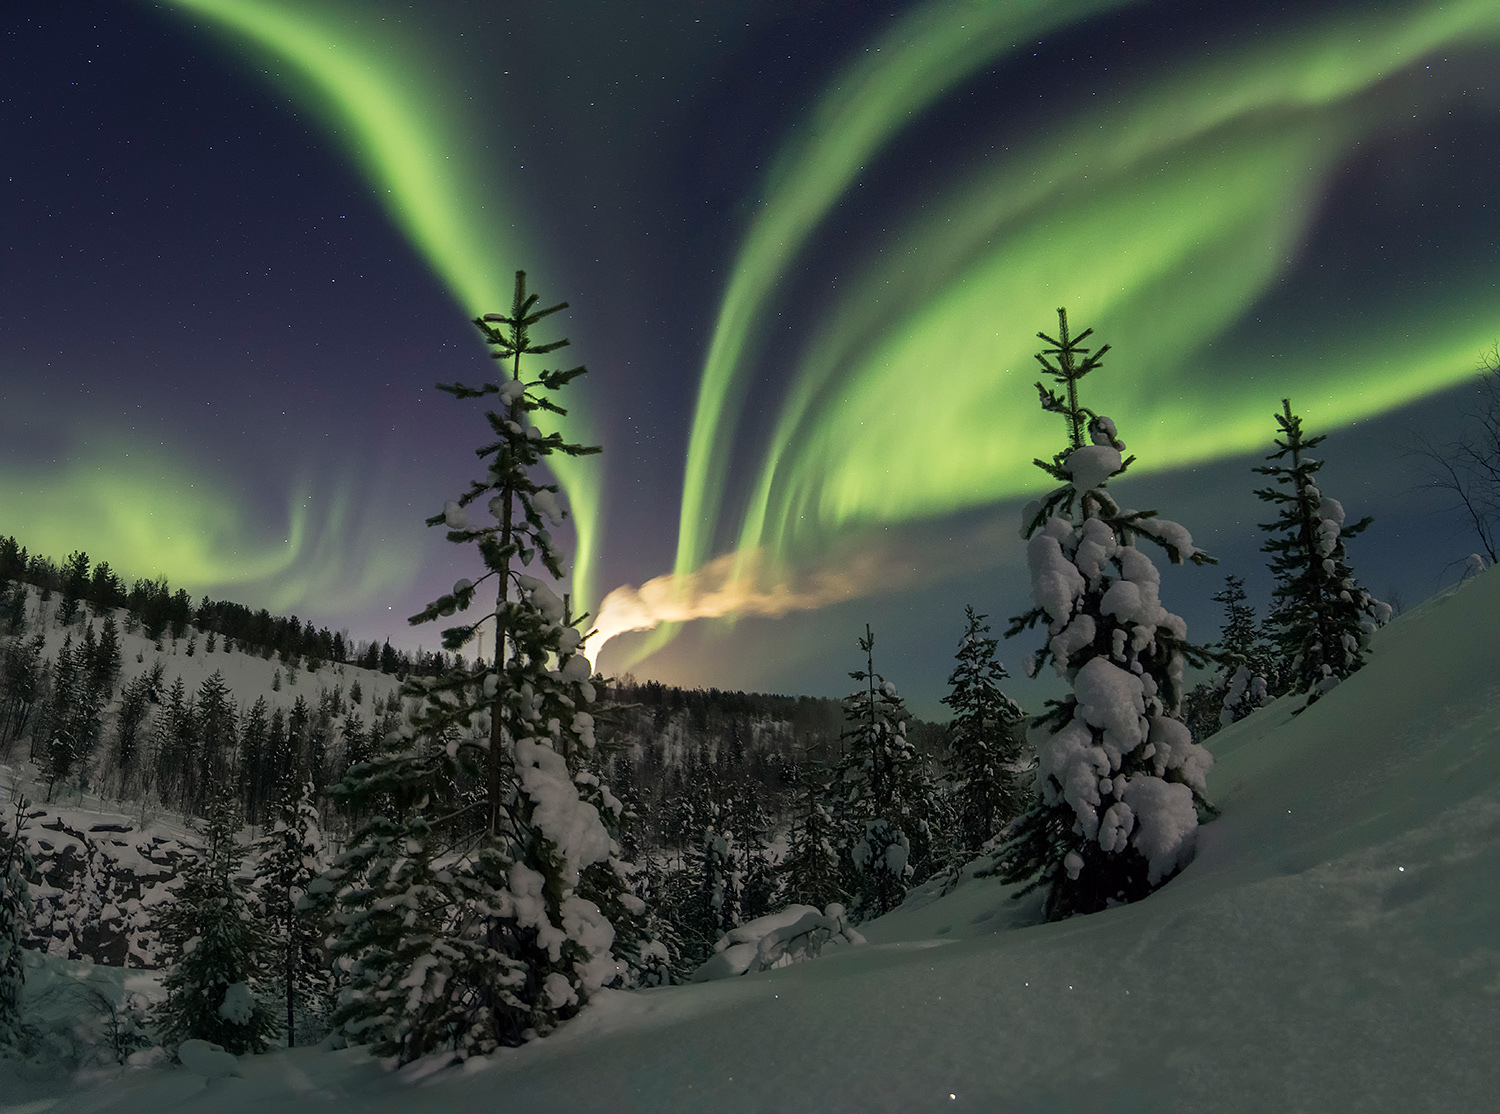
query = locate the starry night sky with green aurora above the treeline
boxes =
[0,0,1500,717]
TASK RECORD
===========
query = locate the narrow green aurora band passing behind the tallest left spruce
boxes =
[171,0,600,601]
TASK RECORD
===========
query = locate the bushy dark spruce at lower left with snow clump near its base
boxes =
[158,786,279,1054]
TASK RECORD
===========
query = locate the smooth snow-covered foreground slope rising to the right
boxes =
[0,573,1500,1114]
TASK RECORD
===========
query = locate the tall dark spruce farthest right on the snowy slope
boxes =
[1256,399,1391,708]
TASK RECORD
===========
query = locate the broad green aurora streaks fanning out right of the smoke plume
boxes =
[677,0,1500,608]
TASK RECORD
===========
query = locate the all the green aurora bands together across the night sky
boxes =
[0,0,1500,652]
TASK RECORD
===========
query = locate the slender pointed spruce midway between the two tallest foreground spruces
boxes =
[834,625,941,921]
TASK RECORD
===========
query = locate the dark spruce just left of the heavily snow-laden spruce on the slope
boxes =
[942,607,1026,862]
